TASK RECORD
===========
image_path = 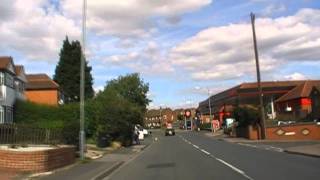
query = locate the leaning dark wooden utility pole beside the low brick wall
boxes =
[250,13,266,139]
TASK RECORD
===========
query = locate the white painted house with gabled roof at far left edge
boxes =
[0,57,26,124]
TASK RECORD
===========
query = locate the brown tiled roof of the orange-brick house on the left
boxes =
[26,74,59,90]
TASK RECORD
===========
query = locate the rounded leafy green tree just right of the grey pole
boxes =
[88,74,150,144]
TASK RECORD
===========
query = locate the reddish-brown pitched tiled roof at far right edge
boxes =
[276,81,320,102]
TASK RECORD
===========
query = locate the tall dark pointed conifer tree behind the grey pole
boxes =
[53,37,94,103]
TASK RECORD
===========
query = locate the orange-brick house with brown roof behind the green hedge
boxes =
[25,74,63,106]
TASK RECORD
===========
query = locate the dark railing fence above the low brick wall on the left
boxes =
[0,124,62,144]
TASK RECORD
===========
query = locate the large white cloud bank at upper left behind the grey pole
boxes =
[0,0,211,62]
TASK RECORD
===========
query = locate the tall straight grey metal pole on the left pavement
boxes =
[79,0,87,160]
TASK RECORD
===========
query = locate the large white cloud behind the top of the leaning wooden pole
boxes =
[169,9,320,80]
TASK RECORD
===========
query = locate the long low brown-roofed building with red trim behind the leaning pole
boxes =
[198,80,320,123]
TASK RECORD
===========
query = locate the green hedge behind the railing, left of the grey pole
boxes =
[14,101,79,145]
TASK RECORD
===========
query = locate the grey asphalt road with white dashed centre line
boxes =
[105,132,320,180]
